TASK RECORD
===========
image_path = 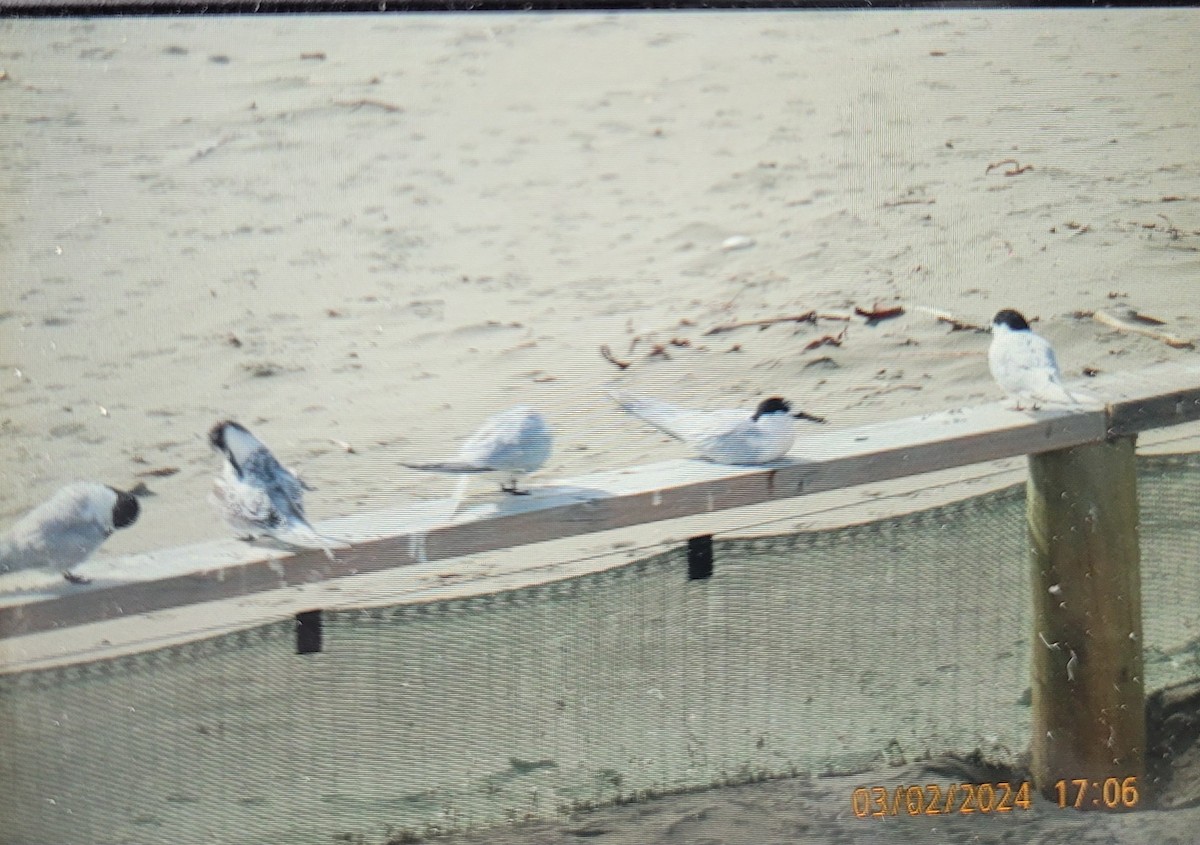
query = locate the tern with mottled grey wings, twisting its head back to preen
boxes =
[209,420,346,561]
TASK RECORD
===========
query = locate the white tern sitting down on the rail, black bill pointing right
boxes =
[608,394,824,466]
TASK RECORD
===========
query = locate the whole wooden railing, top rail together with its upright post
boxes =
[0,364,1200,795]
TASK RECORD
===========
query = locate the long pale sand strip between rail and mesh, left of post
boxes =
[0,451,1032,675]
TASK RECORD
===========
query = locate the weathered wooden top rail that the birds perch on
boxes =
[0,355,1200,637]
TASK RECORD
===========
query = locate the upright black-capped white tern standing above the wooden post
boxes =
[988,308,1080,410]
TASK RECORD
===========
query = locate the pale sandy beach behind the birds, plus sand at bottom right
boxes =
[0,10,1200,844]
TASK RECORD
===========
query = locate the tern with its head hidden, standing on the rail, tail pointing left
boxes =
[402,404,553,496]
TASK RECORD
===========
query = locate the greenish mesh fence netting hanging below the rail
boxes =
[0,456,1200,845]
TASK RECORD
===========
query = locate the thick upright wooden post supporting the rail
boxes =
[1027,437,1146,809]
